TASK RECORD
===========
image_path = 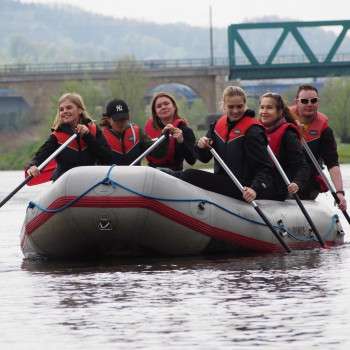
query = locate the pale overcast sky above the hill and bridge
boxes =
[21,0,350,27]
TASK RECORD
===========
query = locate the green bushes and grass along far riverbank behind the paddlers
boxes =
[0,63,350,170]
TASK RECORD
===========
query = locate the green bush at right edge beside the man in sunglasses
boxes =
[320,77,350,143]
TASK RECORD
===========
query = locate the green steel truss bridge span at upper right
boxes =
[228,20,350,80]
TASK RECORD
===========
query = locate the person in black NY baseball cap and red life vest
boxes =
[100,99,152,165]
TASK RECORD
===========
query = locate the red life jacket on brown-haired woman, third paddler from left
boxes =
[145,117,186,167]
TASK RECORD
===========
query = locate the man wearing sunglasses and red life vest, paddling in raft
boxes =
[293,84,346,210]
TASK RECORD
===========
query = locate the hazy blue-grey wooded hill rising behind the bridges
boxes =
[0,0,350,64]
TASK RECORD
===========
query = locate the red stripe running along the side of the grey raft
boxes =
[25,196,332,252]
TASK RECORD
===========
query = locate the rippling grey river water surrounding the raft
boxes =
[0,165,350,350]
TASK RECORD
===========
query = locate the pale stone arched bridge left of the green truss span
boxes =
[0,66,228,123]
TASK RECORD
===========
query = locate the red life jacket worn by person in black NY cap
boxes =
[102,124,140,154]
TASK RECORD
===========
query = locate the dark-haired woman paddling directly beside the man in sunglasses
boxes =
[259,92,311,200]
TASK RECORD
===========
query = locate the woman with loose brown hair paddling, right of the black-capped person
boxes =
[145,92,196,173]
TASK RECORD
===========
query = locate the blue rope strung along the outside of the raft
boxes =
[28,164,339,242]
